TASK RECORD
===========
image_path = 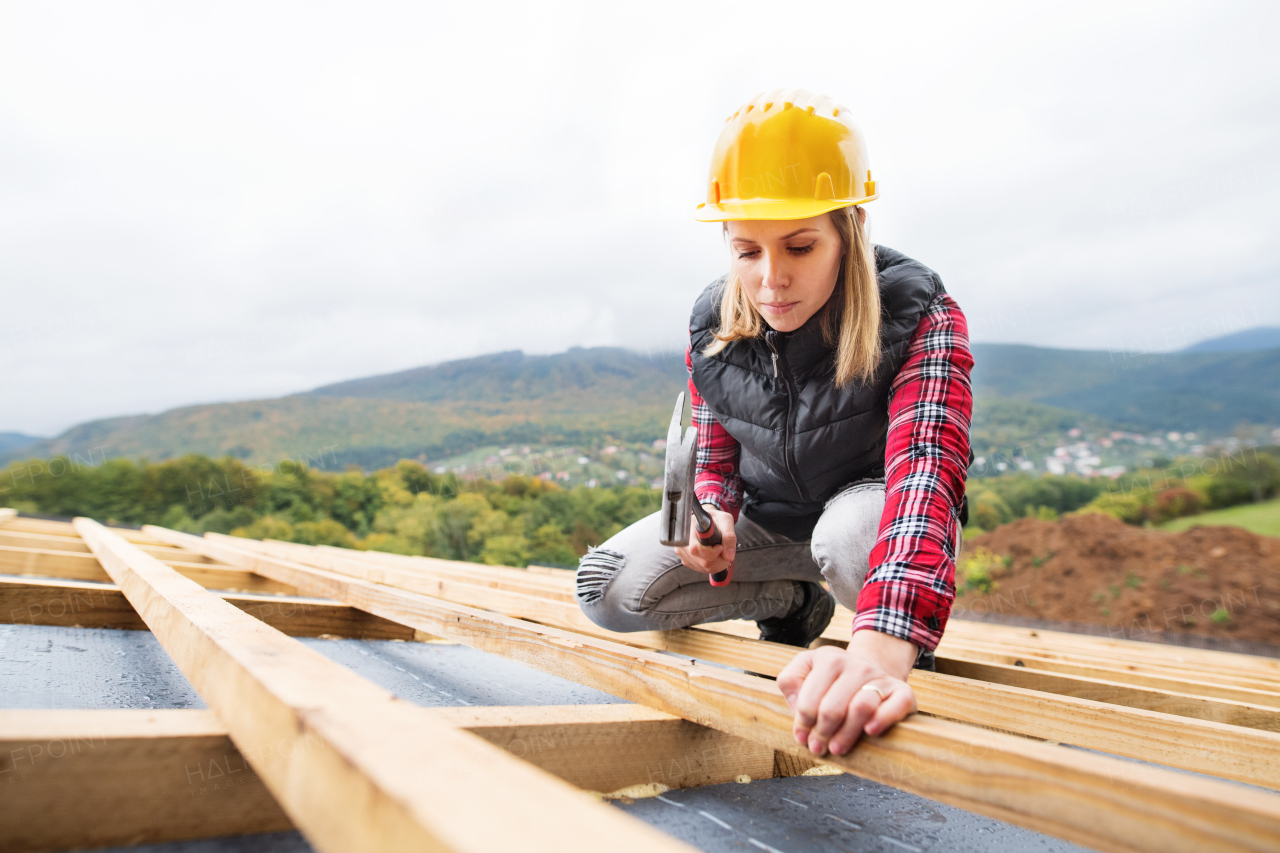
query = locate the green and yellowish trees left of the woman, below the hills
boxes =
[0,455,659,566]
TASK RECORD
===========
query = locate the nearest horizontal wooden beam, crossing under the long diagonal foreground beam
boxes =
[0,704,774,853]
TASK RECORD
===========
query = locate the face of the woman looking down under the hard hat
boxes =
[728,211,861,332]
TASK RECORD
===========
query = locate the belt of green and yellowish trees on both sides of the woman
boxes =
[0,448,1280,566]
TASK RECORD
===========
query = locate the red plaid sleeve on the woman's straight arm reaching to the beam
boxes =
[854,293,973,651]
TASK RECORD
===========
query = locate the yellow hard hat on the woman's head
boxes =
[694,88,877,222]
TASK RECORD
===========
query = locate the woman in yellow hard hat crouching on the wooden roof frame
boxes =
[577,91,973,756]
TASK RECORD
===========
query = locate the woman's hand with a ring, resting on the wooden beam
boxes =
[778,630,916,756]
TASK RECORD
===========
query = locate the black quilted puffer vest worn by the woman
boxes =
[689,246,943,539]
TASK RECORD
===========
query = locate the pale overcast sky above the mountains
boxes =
[0,0,1280,435]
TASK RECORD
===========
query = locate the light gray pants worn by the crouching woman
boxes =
[577,480,884,631]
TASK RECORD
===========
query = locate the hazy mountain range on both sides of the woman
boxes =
[0,343,1280,469]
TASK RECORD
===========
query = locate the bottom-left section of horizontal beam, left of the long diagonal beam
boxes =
[0,710,293,853]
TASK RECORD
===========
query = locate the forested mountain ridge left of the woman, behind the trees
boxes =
[0,347,685,469]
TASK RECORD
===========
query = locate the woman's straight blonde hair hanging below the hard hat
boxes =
[703,206,881,388]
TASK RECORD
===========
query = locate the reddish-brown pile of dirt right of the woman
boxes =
[952,514,1280,644]
